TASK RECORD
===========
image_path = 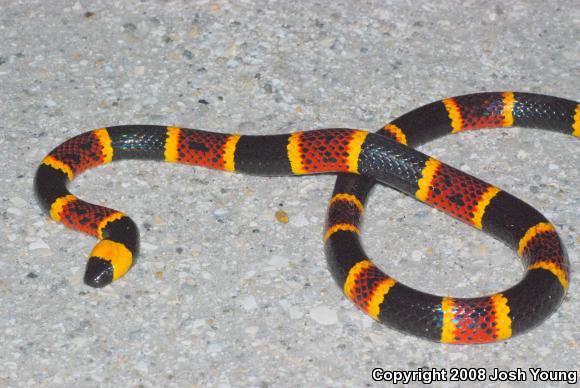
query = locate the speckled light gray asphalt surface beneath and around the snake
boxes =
[0,0,580,387]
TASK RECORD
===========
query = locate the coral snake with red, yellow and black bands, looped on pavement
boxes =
[34,92,580,343]
